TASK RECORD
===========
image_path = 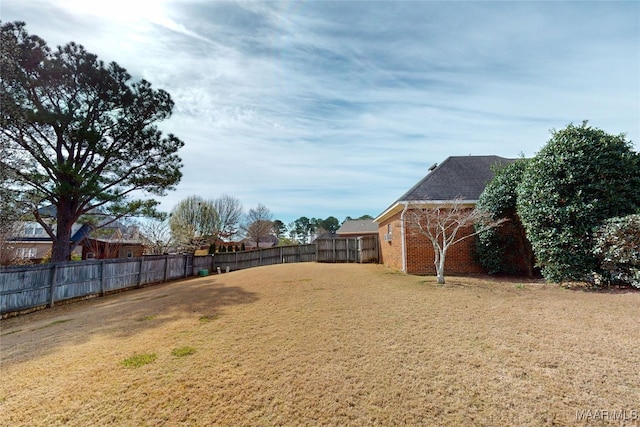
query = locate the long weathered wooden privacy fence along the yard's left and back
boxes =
[0,236,378,315]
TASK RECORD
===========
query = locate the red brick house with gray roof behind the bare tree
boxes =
[374,156,514,274]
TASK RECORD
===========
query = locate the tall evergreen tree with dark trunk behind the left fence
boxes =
[0,22,183,261]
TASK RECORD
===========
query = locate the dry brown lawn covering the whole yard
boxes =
[0,263,640,426]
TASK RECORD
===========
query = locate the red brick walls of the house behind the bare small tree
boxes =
[380,213,484,275]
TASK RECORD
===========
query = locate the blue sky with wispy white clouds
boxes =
[0,0,640,224]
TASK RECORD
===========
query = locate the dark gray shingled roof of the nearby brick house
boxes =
[396,156,514,202]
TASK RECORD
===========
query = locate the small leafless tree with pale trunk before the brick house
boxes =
[407,199,506,284]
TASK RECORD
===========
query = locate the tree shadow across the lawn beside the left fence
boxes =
[0,278,258,366]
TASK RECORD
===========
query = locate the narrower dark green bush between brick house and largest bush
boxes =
[476,158,534,276]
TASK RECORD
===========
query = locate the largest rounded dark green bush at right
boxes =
[517,122,640,282]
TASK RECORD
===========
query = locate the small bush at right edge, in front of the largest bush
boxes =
[593,214,640,288]
